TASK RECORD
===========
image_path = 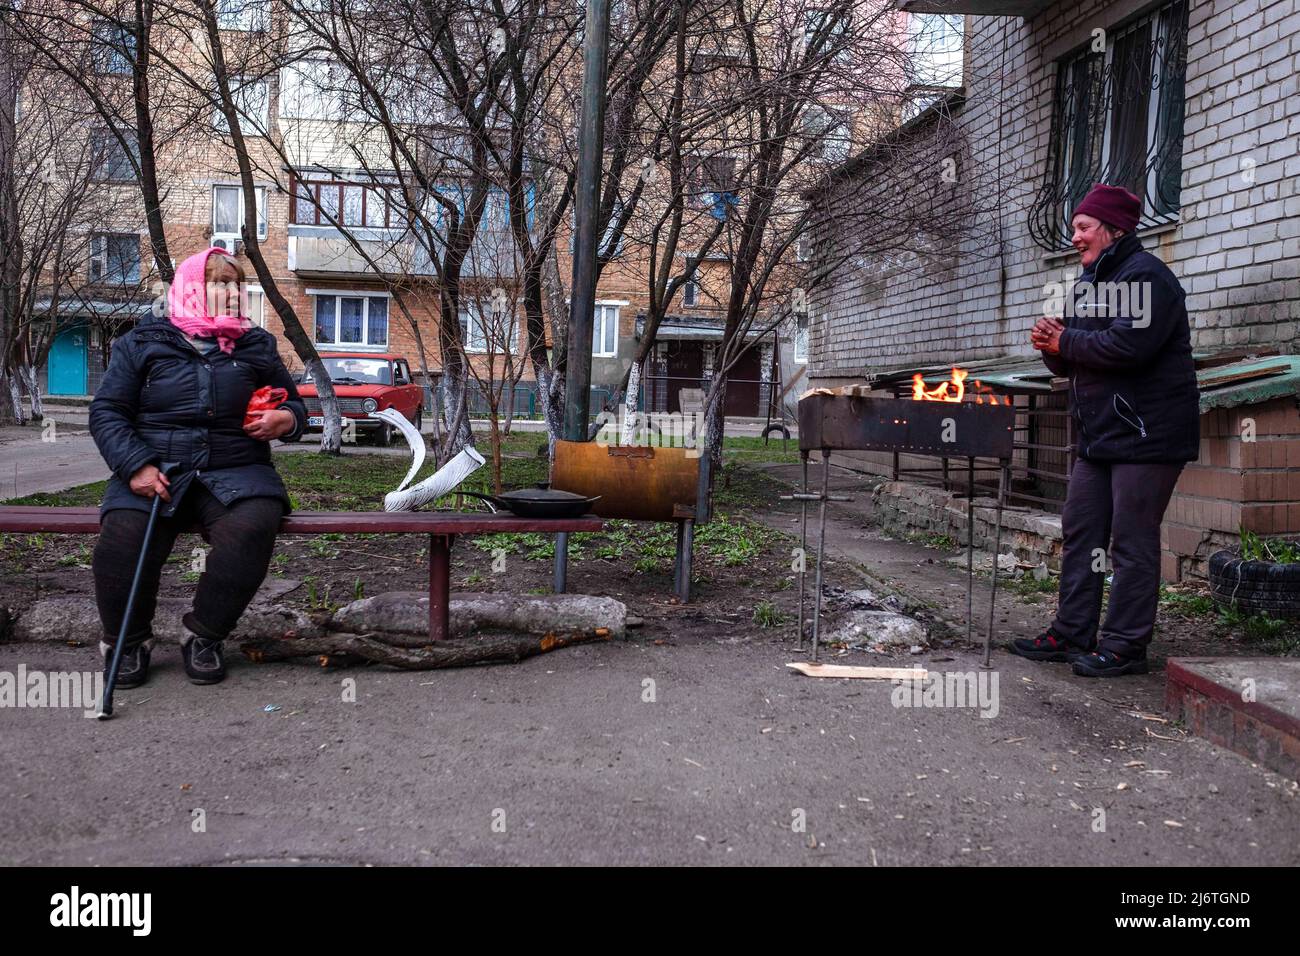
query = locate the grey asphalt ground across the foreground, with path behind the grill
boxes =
[0,455,1300,866]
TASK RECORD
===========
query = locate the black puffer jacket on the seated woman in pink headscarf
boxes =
[90,317,307,516]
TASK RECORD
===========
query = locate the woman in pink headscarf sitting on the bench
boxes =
[90,248,307,688]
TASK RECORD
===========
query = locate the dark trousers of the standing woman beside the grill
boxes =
[1052,458,1183,657]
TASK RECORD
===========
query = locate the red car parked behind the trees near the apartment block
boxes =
[298,352,424,445]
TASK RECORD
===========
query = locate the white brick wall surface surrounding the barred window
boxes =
[809,0,1300,378]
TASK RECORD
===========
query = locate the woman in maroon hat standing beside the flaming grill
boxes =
[1011,185,1200,678]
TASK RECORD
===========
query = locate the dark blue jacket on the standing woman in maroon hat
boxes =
[1044,233,1201,462]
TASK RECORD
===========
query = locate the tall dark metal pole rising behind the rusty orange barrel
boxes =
[564,0,610,441]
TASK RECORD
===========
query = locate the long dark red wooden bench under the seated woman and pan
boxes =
[0,505,605,641]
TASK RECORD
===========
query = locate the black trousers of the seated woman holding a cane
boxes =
[91,481,285,644]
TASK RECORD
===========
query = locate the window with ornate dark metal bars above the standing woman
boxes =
[1030,0,1187,250]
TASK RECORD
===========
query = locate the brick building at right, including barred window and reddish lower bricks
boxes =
[809,0,1300,579]
